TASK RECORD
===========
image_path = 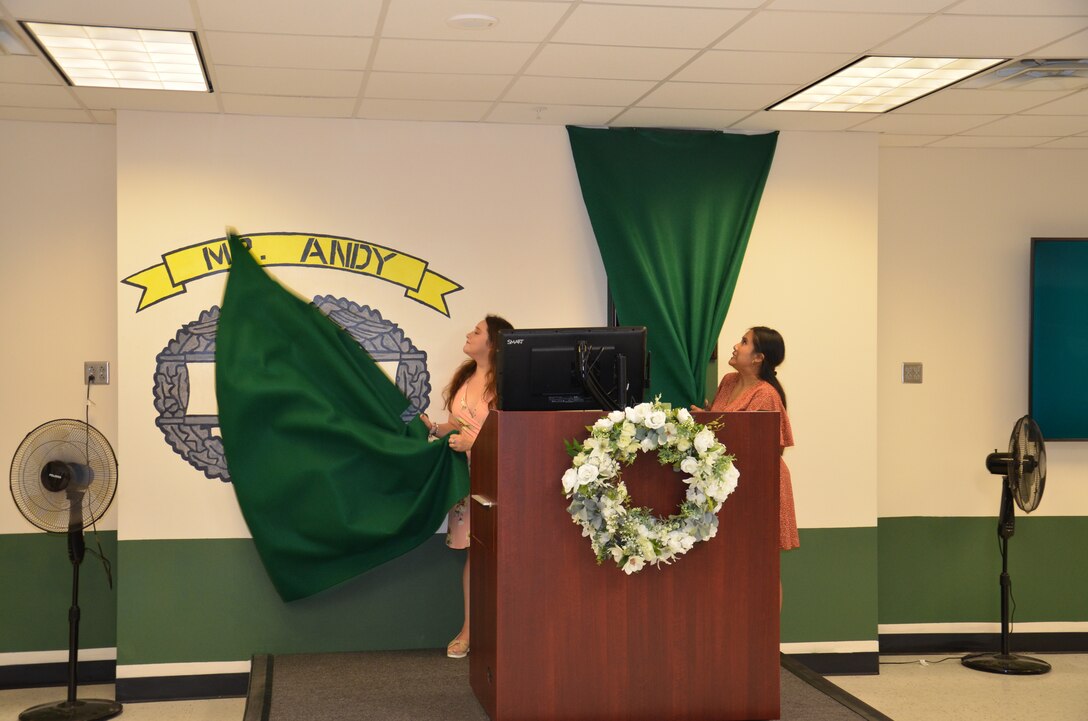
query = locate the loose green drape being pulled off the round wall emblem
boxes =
[215,236,469,600]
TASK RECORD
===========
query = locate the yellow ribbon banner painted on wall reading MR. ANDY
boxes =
[121,233,461,318]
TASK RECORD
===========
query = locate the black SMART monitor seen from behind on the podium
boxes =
[495,326,650,411]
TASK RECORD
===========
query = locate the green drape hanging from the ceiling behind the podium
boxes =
[567,126,778,408]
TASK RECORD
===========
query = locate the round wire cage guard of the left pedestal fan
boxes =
[11,419,118,533]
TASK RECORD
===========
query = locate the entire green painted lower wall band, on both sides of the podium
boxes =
[0,517,1088,664]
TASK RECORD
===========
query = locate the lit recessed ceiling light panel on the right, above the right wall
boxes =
[767,55,1006,113]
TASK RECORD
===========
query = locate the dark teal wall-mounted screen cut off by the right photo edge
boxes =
[1028,238,1088,440]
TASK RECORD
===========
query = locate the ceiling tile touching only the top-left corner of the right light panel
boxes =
[715,12,925,53]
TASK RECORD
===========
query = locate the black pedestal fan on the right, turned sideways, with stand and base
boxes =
[962,415,1050,675]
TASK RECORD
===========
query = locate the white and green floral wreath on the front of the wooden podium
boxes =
[562,397,740,574]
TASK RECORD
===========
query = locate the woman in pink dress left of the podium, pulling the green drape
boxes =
[420,315,514,658]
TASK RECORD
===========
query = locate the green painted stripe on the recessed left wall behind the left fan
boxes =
[0,531,119,654]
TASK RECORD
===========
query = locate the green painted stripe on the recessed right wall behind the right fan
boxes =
[878,515,1088,623]
